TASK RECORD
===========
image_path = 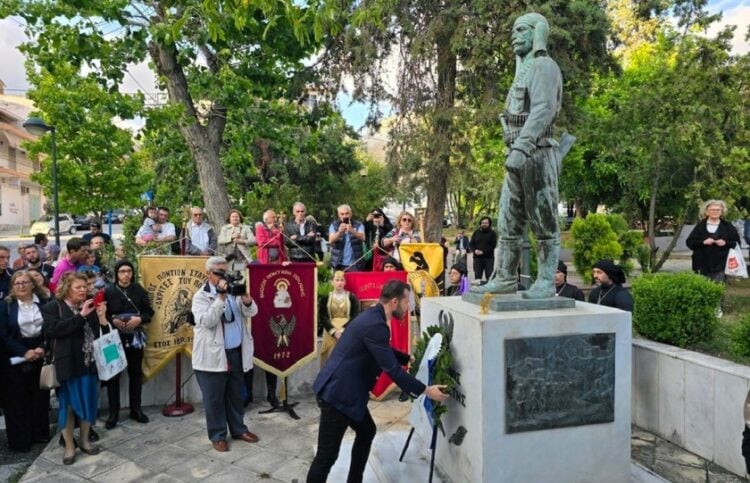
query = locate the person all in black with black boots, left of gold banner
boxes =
[104,260,154,429]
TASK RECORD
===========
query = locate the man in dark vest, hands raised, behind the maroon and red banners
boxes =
[328,205,365,271]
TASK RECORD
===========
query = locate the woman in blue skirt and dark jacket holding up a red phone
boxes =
[42,272,108,465]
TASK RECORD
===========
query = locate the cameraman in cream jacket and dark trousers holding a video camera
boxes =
[192,257,258,452]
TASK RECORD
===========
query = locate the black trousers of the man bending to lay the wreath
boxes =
[307,398,377,483]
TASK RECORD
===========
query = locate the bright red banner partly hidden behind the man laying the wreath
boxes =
[344,272,411,401]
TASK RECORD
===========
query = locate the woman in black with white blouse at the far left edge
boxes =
[0,270,50,453]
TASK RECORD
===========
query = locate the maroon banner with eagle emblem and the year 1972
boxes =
[248,263,318,377]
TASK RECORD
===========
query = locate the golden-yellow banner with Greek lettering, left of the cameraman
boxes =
[138,256,207,379]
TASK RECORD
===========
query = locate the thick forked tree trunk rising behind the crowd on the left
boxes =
[149,36,229,225]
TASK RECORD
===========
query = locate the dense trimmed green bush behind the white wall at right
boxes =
[632,272,724,347]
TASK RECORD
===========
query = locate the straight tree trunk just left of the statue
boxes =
[423,35,456,242]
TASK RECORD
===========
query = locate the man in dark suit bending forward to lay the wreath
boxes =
[307,280,448,483]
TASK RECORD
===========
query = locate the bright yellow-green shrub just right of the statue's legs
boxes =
[569,213,623,285]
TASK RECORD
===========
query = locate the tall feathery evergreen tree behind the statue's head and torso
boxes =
[320,0,612,239]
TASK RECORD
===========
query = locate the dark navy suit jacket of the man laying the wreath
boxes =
[313,304,425,421]
